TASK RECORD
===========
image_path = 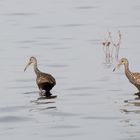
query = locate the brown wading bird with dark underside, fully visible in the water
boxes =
[24,57,56,97]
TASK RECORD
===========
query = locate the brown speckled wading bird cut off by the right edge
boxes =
[113,58,140,97]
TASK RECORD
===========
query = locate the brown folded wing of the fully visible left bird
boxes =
[37,73,56,85]
